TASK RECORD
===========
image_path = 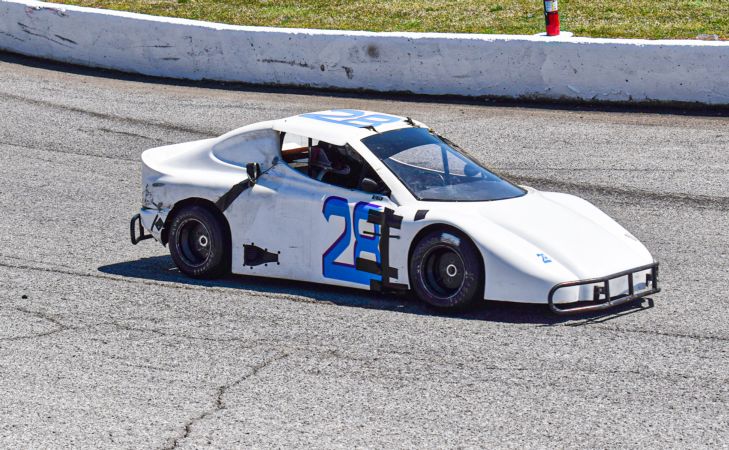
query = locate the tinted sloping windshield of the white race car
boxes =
[362,128,526,202]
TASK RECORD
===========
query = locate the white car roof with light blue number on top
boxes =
[273,109,425,145]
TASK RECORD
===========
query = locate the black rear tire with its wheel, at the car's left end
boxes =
[168,205,230,278]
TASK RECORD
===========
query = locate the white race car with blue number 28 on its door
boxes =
[130,109,659,313]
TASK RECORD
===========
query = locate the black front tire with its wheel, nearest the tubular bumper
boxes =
[410,230,483,309]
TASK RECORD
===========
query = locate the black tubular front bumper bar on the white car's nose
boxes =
[547,262,661,315]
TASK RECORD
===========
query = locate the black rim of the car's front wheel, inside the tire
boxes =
[421,245,466,298]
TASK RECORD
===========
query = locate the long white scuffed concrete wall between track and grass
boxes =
[0,0,729,105]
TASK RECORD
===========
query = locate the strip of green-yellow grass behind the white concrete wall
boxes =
[52,0,729,39]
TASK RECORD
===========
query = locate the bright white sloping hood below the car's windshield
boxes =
[418,189,653,279]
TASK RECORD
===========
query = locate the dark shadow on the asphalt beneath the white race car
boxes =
[98,255,653,326]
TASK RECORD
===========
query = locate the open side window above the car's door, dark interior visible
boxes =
[281,133,390,195]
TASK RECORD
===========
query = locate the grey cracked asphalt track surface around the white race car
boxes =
[0,54,729,448]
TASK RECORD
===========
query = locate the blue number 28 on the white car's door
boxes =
[321,197,381,285]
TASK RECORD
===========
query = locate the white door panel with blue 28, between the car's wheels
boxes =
[226,164,395,289]
